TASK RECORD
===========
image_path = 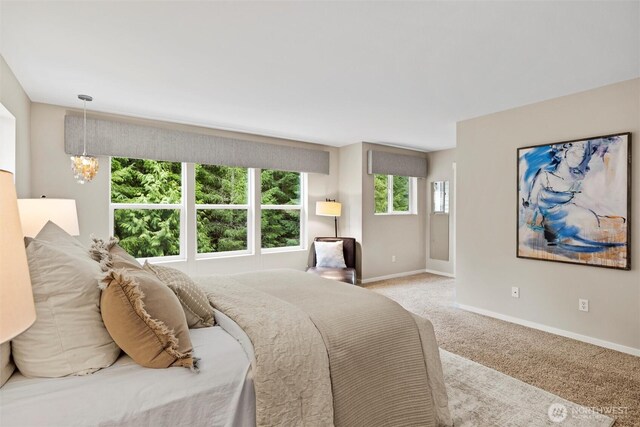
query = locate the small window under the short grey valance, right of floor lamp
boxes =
[373,175,415,214]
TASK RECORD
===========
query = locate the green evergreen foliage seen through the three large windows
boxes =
[111,157,301,258]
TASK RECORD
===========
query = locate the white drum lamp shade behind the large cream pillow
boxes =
[18,197,80,237]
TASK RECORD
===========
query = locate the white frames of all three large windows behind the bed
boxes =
[108,156,308,263]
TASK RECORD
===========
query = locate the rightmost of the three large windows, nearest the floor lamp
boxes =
[260,169,303,249]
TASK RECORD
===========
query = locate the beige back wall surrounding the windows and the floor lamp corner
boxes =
[31,103,436,280]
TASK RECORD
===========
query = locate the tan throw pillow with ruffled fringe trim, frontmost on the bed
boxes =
[101,269,197,371]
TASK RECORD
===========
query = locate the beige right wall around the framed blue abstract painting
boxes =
[456,79,640,349]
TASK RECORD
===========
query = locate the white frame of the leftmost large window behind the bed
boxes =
[109,156,187,263]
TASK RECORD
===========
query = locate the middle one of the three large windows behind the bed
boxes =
[195,165,250,254]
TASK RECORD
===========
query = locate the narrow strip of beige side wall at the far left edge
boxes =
[0,55,31,197]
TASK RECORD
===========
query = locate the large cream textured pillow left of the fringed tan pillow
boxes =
[11,222,120,377]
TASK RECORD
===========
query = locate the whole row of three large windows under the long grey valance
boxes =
[109,157,306,259]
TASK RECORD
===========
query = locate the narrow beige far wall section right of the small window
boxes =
[426,148,456,275]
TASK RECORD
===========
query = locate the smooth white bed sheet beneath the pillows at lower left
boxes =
[0,326,255,427]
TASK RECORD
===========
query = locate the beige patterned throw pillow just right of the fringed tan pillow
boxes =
[144,262,214,328]
